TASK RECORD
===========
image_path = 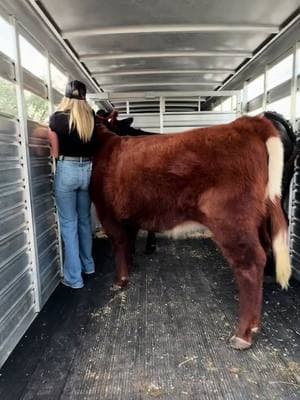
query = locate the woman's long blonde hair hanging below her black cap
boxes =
[57,97,95,142]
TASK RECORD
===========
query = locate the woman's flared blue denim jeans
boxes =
[54,160,95,288]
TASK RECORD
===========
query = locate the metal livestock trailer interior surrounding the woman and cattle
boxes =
[0,0,300,400]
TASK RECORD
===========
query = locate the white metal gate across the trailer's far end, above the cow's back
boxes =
[88,90,242,133]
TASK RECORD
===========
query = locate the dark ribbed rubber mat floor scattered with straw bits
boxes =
[0,238,300,400]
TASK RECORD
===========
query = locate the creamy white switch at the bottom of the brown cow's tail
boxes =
[272,230,292,289]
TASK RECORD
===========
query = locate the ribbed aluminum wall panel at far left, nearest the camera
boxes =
[0,116,35,365]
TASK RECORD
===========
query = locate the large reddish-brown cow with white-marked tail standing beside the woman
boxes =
[91,117,291,349]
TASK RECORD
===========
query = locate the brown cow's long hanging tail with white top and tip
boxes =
[266,136,292,289]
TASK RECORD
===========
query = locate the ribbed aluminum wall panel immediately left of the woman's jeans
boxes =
[27,121,60,305]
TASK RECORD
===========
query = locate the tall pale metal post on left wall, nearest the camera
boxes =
[10,17,41,312]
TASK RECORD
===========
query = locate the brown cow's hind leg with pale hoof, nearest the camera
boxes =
[215,224,266,350]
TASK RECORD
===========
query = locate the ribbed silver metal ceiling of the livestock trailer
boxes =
[37,0,299,92]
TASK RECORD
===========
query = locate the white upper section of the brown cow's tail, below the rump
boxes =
[266,137,283,202]
